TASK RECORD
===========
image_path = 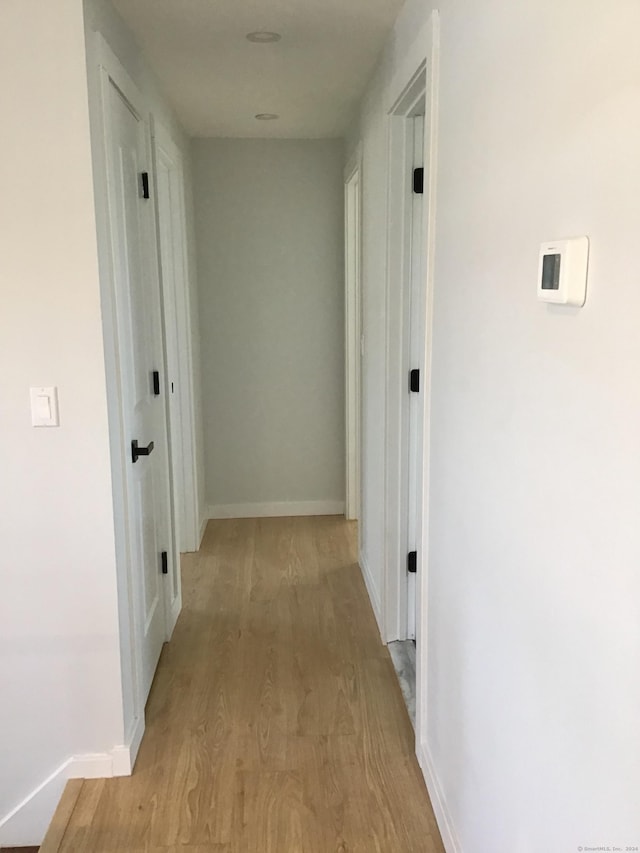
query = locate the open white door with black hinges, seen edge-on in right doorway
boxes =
[407,116,426,640]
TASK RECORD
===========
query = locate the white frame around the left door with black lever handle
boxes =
[88,33,175,775]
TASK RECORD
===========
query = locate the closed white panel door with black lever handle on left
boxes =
[105,78,172,702]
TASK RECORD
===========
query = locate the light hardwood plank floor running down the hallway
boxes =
[42,517,444,853]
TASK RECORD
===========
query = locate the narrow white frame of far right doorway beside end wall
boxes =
[344,146,362,520]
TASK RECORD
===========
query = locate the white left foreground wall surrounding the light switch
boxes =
[0,0,123,845]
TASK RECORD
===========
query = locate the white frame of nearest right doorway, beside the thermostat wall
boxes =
[382,11,439,748]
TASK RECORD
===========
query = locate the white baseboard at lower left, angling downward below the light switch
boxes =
[0,724,144,847]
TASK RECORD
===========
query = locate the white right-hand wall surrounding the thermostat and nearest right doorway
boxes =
[351,0,640,853]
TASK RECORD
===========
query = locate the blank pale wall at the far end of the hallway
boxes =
[193,139,345,515]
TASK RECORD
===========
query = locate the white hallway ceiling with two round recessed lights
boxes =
[113,0,403,138]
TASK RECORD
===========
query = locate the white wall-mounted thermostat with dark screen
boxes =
[538,237,589,308]
